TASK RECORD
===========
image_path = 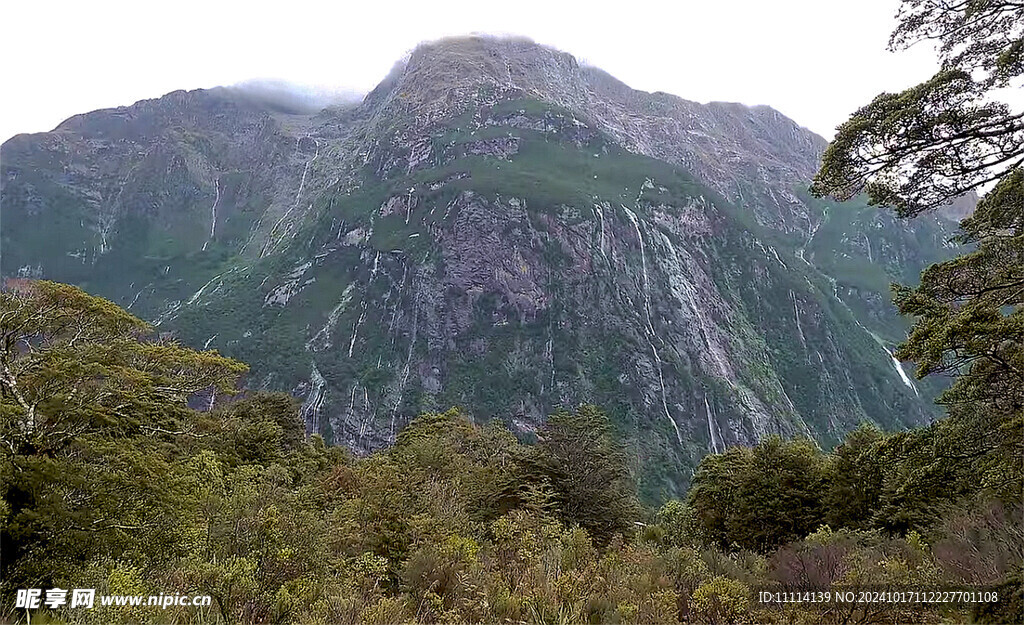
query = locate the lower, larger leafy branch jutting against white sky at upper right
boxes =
[811,69,1024,216]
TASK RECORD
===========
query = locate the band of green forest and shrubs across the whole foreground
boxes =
[0,283,1021,625]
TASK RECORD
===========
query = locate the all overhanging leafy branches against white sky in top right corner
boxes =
[811,0,1024,216]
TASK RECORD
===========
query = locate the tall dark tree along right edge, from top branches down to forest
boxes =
[811,0,1024,506]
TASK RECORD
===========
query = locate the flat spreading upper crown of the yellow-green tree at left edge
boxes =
[0,282,248,456]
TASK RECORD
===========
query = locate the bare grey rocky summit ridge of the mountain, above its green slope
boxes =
[364,36,826,232]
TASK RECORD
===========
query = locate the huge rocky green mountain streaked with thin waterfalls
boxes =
[0,37,953,498]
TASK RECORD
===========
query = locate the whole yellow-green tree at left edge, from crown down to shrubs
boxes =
[0,281,246,586]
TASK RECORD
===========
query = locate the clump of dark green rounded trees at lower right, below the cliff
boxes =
[679,409,1022,552]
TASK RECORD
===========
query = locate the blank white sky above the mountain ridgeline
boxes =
[0,0,936,140]
